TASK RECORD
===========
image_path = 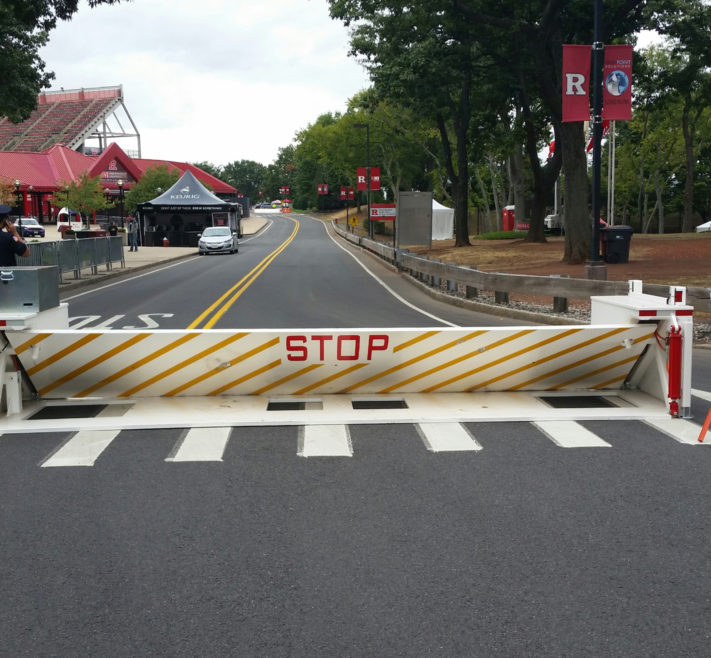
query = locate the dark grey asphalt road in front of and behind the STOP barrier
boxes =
[0,213,711,656]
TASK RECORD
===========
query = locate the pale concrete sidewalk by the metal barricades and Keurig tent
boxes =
[57,215,267,292]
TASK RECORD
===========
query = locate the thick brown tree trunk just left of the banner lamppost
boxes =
[556,122,592,264]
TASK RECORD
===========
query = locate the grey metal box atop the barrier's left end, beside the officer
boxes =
[0,265,59,317]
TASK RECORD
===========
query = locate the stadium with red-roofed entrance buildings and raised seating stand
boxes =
[0,85,242,244]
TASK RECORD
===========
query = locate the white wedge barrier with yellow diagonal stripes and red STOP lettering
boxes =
[0,282,692,416]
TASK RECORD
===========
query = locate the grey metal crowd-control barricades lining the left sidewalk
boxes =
[23,236,126,283]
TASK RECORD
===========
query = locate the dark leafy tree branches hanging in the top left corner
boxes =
[0,0,126,123]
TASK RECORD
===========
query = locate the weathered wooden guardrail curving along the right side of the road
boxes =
[333,224,711,313]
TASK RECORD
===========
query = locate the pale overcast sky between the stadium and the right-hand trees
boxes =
[41,0,369,165]
